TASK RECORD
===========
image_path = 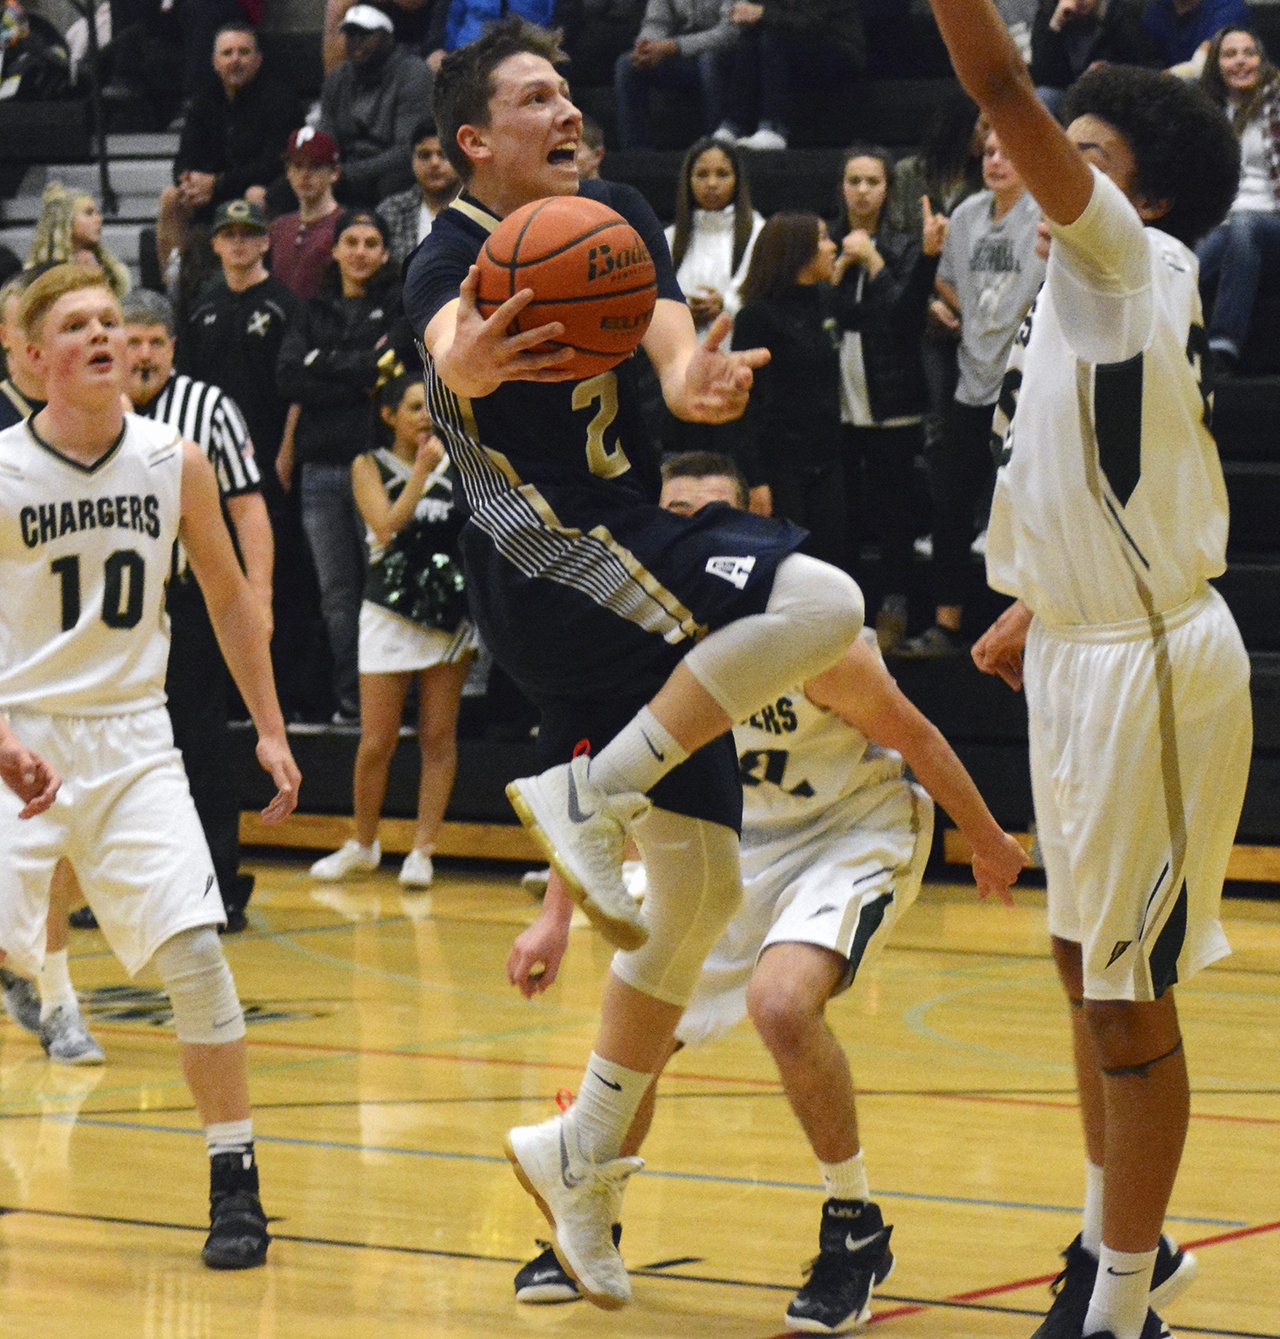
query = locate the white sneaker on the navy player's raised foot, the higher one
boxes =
[506,755,649,949]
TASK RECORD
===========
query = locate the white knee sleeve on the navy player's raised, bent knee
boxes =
[684,553,864,722]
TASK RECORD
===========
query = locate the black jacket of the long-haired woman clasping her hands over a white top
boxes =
[831,222,939,422]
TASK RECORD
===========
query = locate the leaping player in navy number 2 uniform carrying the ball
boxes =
[404,17,862,1307]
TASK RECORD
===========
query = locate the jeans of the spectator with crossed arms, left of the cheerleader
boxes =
[300,462,364,711]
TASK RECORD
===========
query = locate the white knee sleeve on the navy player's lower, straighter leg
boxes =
[613,809,742,1008]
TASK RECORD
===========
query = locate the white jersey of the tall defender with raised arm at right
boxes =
[987,170,1226,624]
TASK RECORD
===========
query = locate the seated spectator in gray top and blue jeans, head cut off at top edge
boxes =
[613,0,736,149]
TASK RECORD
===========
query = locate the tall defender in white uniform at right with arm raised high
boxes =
[931,0,1252,1339]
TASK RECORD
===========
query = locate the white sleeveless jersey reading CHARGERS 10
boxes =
[0,414,182,716]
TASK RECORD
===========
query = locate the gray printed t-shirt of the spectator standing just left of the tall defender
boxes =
[937,190,1044,404]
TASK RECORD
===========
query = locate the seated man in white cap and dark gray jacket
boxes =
[320,4,434,206]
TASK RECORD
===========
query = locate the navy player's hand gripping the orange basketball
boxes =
[439,265,573,400]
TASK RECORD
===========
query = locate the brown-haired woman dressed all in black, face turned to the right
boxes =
[732,213,848,566]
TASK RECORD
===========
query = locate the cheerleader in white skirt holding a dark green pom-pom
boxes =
[311,368,475,888]
